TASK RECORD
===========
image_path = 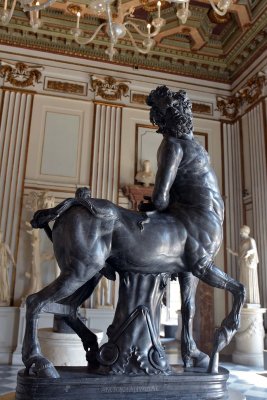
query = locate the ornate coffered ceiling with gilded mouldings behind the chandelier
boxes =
[0,0,267,83]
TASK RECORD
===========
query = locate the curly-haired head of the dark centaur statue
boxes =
[147,86,193,139]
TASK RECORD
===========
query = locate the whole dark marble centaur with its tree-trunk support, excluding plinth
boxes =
[23,86,245,388]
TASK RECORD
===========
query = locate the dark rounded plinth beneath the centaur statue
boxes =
[16,366,229,400]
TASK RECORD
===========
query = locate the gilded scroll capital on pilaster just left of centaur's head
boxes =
[91,75,129,100]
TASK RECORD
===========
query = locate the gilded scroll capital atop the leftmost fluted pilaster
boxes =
[0,62,43,88]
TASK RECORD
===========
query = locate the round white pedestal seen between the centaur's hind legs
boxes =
[38,328,104,366]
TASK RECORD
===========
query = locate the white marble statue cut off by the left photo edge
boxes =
[0,231,15,307]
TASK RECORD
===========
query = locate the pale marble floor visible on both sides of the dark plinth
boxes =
[0,362,267,400]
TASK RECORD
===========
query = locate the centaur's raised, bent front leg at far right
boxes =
[193,262,245,373]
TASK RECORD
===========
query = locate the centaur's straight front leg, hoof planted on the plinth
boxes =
[178,272,209,368]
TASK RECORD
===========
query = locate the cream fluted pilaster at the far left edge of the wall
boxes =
[0,90,33,254]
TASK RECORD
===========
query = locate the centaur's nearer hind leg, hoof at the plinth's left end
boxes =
[22,267,101,378]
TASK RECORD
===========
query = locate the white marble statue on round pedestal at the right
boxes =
[228,225,260,305]
